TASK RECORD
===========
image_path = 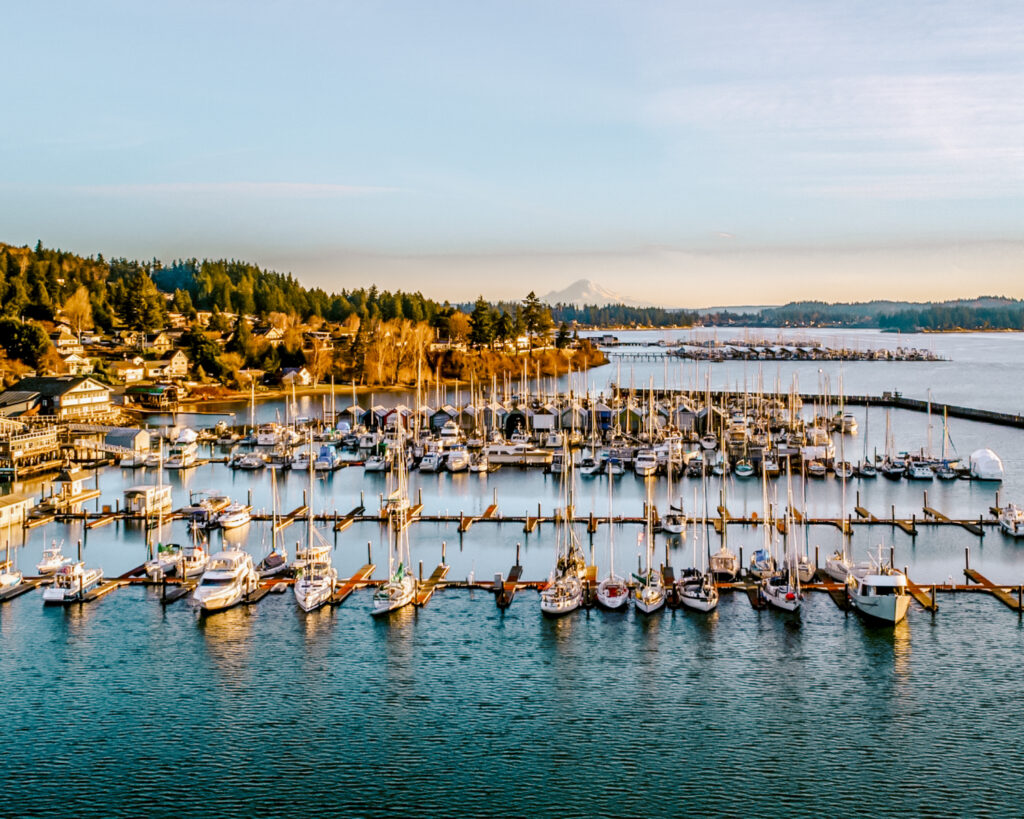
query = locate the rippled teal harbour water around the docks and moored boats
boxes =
[0,334,1024,817]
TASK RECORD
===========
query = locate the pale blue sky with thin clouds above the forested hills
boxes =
[0,0,1024,307]
